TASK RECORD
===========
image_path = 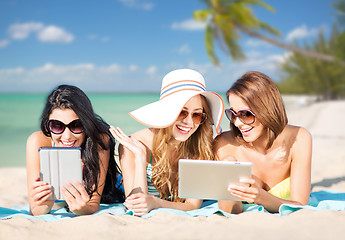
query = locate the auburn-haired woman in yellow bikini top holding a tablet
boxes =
[214,72,312,213]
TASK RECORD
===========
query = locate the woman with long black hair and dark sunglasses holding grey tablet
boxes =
[26,85,124,215]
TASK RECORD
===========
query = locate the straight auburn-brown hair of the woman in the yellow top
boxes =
[226,71,288,149]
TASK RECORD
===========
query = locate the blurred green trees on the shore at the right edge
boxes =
[277,24,345,100]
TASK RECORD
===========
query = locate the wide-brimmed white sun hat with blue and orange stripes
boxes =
[129,69,224,134]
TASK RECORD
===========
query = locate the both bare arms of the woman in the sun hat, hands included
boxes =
[110,127,202,216]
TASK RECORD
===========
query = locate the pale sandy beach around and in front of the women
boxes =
[0,96,345,239]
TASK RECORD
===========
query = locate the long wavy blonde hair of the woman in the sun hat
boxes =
[152,95,214,202]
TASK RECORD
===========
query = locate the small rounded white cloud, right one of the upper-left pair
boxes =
[37,25,74,43]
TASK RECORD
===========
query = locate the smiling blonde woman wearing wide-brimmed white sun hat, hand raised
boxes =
[110,69,224,216]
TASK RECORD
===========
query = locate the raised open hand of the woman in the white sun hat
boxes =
[109,126,146,160]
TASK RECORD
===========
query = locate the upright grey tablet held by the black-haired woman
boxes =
[39,147,83,200]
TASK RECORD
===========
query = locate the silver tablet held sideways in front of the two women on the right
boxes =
[178,159,252,201]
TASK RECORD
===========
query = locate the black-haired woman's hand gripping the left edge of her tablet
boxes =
[31,178,54,213]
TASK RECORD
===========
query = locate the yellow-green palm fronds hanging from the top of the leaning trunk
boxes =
[193,0,280,65]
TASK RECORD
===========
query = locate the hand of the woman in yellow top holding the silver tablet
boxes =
[228,178,266,204]
